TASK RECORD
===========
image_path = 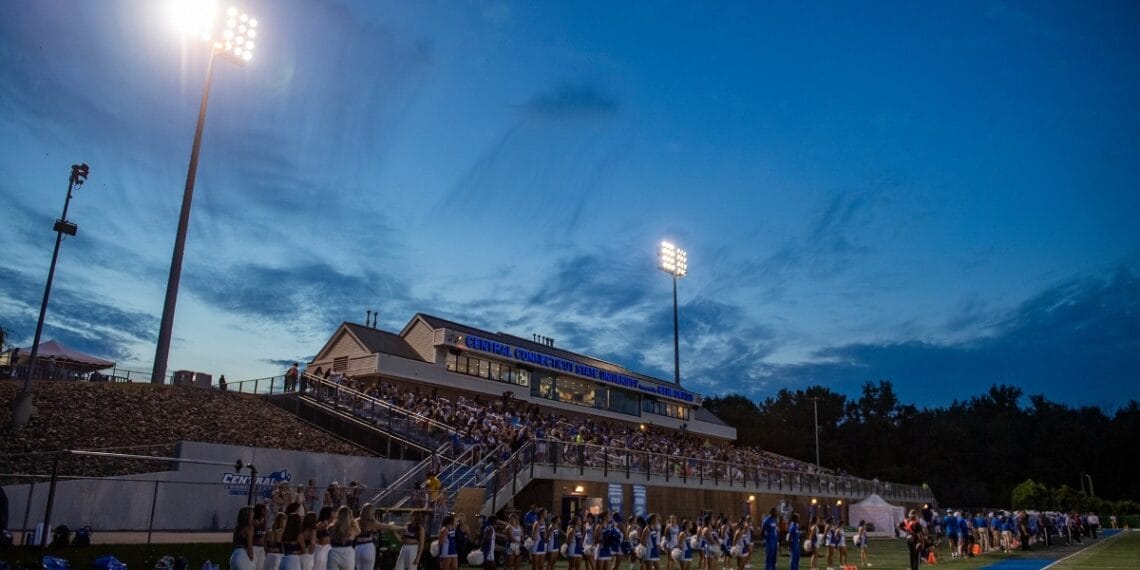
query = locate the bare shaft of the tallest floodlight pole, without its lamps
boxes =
[150,48,218,384]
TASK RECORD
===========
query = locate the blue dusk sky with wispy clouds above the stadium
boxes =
[0,0,1140,408]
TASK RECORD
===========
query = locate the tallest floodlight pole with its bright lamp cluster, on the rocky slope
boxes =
[150,3,258,384]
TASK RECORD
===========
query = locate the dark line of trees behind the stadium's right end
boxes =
[703,381,1140,508]
